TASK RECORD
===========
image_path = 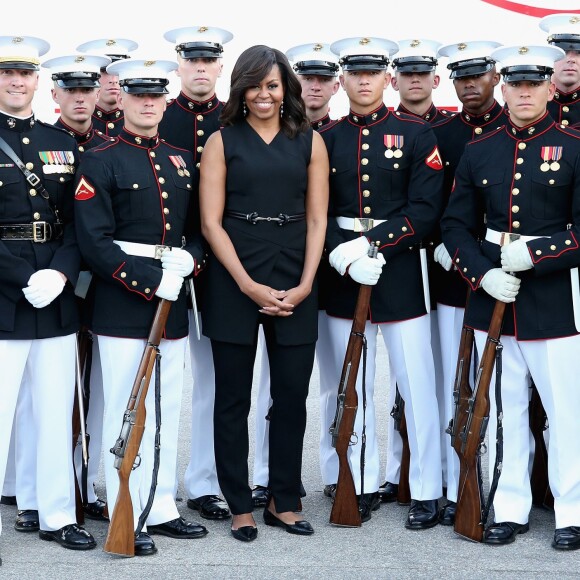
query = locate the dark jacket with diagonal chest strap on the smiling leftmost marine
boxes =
[0,113,80,340]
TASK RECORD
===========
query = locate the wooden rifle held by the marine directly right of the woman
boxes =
[329,242,379,528]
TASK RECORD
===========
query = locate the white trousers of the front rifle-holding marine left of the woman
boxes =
[97,335,187,526]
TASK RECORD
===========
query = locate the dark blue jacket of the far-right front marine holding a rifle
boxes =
[442,114,580,340]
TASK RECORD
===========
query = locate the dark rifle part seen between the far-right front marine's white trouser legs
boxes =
[529,383,554,509]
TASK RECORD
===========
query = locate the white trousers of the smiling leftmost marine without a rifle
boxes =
[0,334,76,530]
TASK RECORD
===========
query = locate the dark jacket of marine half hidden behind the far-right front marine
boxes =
[429,101,507,308]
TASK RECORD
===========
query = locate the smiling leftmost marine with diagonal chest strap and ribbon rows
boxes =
[0,36,96,550]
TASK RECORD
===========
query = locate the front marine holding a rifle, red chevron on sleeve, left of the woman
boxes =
[75,59,207,555]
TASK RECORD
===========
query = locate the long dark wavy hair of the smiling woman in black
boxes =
[220,44,310,138]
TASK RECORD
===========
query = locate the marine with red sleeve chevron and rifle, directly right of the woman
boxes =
[321,37,443,529]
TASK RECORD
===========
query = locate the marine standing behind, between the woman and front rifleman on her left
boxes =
[159,26,233,519]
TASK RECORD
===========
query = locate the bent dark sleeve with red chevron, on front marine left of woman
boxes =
[75,151,162,300]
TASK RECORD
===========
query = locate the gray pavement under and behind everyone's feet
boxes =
[0,338,580,580]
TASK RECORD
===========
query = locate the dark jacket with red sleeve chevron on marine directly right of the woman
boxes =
[320,104,443,322]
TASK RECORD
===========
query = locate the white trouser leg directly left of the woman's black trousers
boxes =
[184,310,220,499]
